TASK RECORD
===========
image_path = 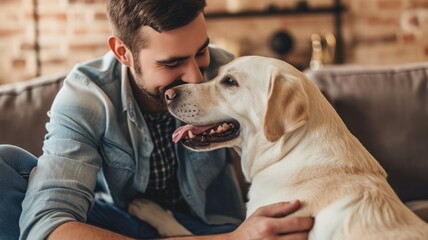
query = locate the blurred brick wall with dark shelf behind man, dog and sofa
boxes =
[0,0,428,84]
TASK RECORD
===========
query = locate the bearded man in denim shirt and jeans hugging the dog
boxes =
[0,0,312,239]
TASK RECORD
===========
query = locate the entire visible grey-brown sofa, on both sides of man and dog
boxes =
[0,63,428,222]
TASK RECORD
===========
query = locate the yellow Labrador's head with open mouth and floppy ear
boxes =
[165,56,309,151]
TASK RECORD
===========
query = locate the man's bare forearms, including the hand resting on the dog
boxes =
[48,201,313,240]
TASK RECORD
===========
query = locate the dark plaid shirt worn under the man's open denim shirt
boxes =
[142,112,187,212]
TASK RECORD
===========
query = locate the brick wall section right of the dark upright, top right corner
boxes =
[347,0,428,64]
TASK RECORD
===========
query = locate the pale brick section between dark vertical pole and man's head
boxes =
[39,0,110,75]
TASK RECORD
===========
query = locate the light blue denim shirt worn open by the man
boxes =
[20,47,244,239]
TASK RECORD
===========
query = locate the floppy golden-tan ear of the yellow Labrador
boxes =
[263,71,309,142]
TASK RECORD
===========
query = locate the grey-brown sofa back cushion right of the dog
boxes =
[305,63,428,201]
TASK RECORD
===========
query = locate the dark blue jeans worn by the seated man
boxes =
[0,145,237,239]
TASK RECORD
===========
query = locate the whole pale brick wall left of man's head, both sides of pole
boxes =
[0,0,110,84]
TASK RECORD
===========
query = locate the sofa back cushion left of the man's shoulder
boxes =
[0,74,65,156]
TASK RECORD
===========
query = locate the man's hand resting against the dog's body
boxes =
[230,201,314,240]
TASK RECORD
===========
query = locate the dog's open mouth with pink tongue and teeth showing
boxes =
[172,120,240,150]
